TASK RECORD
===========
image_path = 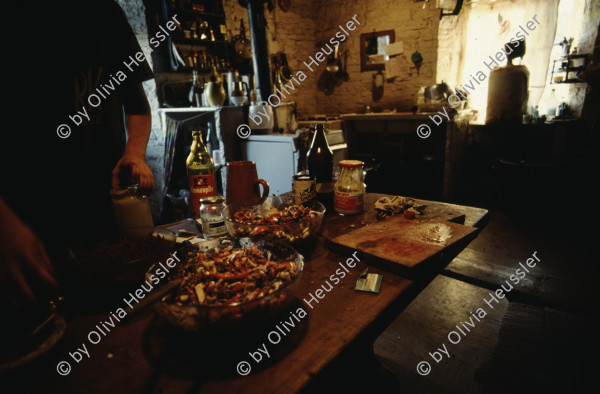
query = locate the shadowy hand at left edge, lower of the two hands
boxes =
[0,199,57,306]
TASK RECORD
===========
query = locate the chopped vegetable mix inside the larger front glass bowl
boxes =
[163,244,298,306]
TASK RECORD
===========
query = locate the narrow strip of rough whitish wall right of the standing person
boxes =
[117,0,165,222]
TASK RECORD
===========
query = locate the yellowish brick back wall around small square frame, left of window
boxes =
[315,0,440,113]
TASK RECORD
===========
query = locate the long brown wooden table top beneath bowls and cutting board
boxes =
[9,194,487,393]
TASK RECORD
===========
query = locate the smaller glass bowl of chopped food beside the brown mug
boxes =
[223,196,325,246]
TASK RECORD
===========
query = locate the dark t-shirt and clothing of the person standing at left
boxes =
[1,0,153,251]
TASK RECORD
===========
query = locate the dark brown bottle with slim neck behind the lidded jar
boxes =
[306,124,333,210]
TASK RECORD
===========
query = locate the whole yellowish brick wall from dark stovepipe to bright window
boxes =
[224,0,440,116]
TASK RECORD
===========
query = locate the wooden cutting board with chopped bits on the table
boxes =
[329,214,477,273]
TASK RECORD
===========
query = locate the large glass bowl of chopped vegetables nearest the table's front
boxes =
[147,238,304,332]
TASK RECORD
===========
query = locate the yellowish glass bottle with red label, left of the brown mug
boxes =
[185,130,217,218]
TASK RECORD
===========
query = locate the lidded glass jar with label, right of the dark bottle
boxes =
[333,160,366,215]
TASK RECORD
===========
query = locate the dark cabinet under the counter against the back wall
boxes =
[342,113,466,200]
